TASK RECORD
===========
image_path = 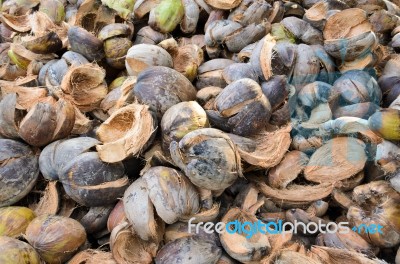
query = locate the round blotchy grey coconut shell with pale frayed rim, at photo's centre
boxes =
[170,128,242,191]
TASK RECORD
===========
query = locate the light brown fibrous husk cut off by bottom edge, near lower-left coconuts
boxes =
[68,249,117,264]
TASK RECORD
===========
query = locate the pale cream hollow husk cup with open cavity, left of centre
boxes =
[96,104,157,162]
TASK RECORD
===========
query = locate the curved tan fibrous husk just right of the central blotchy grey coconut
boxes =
[233,125,292,168]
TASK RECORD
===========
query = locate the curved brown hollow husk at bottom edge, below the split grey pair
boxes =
[110,222,158,264]
